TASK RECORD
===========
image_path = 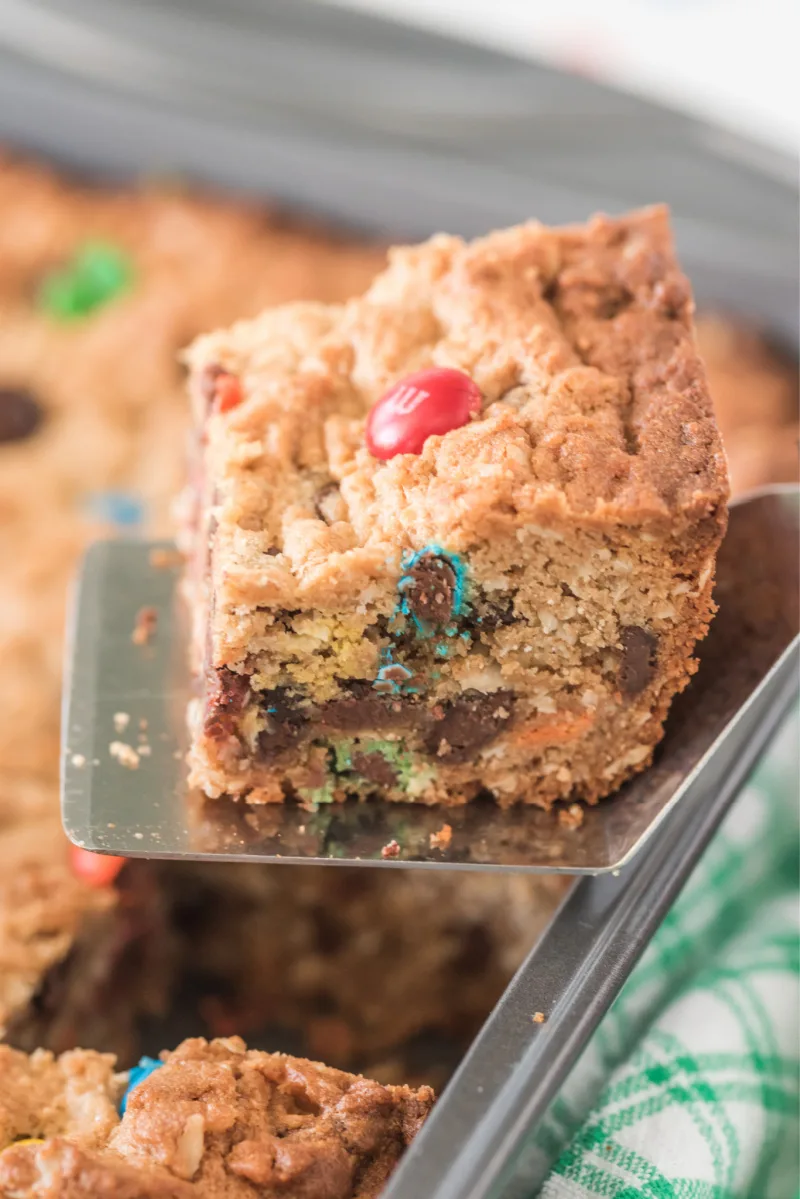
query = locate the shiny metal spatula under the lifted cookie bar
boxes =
[62,487,800,874]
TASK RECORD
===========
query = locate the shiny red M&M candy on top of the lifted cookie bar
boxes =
[366,367,482,462]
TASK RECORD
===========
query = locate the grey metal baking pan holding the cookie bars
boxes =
[0,0,799,1199]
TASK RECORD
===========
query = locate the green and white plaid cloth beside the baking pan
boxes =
[536,717,800,1199]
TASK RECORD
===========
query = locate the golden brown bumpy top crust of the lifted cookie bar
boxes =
[188,209,727,642]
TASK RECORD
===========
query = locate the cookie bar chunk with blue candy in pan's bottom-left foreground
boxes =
[0,1037,433,1199]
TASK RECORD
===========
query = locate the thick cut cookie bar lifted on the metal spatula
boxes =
[184,209,728,806]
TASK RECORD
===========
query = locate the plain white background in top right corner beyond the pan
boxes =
[327,0,800,152]
